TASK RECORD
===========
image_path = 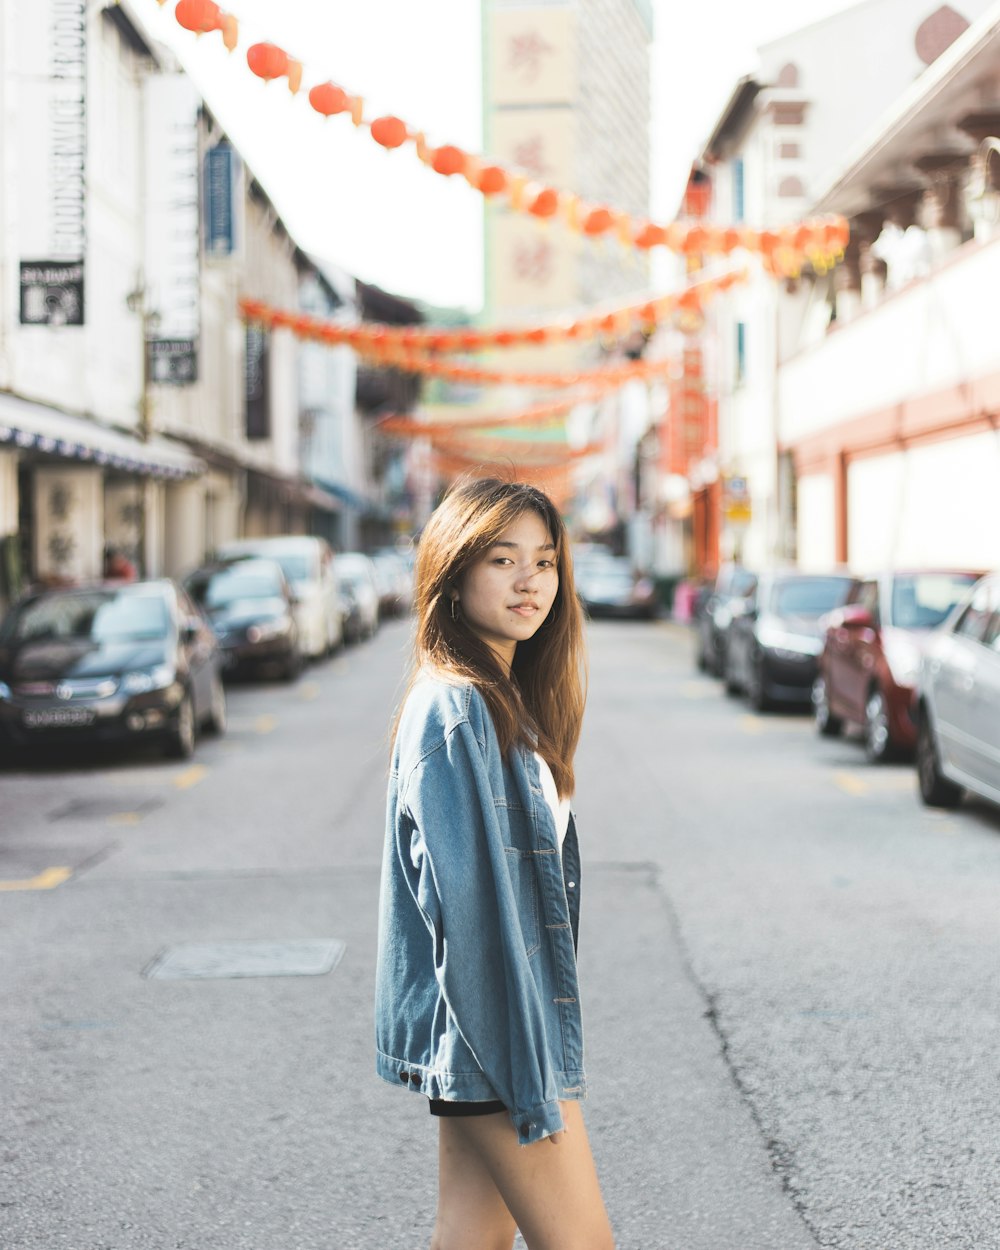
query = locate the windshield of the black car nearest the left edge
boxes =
[5,591,170,643]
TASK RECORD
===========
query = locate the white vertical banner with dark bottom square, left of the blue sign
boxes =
[143,74,201,385]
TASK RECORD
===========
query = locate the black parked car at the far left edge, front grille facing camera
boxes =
[0,580,226,758]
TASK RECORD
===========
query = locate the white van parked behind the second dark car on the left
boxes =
[216,535,344,660]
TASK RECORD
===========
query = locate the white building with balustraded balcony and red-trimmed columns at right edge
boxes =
[778,5,1000,570]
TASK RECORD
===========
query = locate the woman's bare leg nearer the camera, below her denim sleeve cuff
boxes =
[439,1103,615,1250]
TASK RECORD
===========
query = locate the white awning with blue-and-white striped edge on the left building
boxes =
[0,394,205,480]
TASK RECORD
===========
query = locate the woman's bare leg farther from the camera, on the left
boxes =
[430,1111,518,1250]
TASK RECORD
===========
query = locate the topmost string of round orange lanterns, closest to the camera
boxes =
[158,0,850,278]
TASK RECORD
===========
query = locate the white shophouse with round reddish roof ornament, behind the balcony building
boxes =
[691,0,989,568]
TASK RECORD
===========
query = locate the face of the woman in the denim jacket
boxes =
[458,510,559,669]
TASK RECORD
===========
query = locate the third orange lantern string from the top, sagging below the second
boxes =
[240,300,669,388]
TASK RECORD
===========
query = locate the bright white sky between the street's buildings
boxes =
[134,0,854,311]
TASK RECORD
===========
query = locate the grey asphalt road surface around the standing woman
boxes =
[0,623,1000,1250]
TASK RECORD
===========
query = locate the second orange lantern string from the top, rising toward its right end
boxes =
[240,270,748,354]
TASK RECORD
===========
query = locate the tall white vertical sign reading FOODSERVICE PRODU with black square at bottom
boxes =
[15,0,88,325]
